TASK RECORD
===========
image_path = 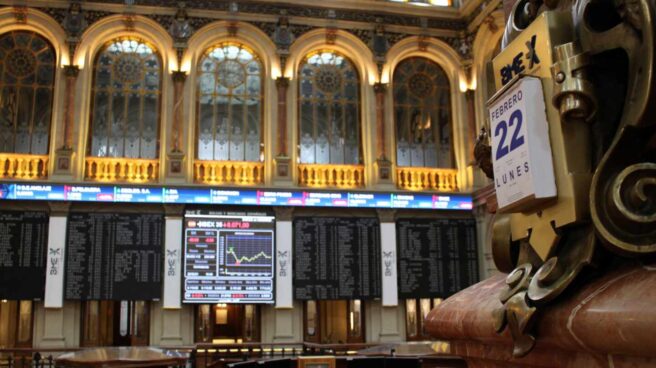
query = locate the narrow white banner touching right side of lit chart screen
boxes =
[274,208,294,308]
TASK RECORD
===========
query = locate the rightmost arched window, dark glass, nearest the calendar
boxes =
[393,57,453,168]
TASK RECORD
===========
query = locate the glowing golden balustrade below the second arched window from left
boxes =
[85,157,159,183]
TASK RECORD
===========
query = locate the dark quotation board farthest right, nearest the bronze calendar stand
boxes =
[396,219,479,299]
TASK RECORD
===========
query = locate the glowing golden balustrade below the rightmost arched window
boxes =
[396,167,458,192]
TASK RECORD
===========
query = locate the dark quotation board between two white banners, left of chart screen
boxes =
[64,213,164,300]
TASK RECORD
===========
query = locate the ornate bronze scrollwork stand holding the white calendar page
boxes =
[484,0,656,357]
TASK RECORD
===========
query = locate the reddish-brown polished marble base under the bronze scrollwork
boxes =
[426,263,656,368]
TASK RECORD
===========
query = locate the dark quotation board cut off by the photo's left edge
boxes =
[0,211,49,300]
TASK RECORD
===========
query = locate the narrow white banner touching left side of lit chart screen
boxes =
[162,215,182,309]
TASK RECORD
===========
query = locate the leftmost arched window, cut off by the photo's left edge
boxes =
[0,31,56,155]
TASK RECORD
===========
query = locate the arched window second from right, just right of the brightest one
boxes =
[298,51,361,164]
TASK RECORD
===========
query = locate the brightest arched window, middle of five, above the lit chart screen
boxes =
[197,43,263,161]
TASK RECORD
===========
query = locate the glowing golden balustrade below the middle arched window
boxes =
[194,160,264,185]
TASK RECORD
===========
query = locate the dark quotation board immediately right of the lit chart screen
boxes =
[293,217,381,300]
